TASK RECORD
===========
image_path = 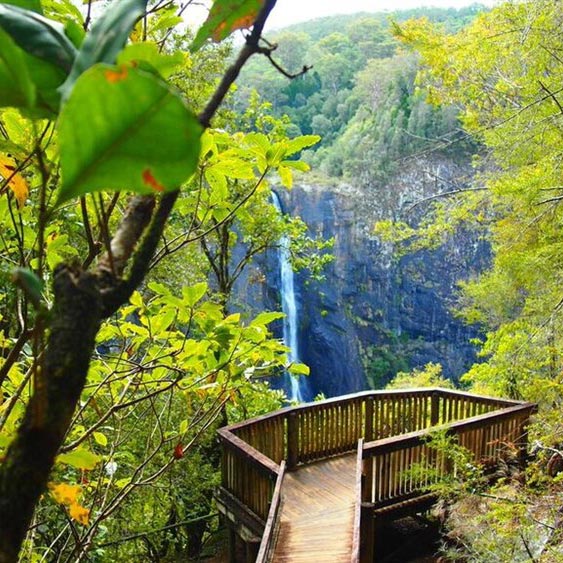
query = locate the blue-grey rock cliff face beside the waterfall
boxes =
[236,159,488,396]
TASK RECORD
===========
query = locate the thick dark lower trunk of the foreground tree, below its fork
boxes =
[0,266,101,563]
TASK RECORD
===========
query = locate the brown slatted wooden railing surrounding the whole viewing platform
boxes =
[219,389,535,560]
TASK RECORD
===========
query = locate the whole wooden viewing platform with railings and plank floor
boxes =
[217,389,536,563]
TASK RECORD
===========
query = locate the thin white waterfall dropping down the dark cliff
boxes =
[272,192,308,403]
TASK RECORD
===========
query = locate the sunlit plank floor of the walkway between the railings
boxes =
[272,454,356,563]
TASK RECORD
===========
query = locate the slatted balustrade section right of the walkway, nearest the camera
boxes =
[363,404,536,508]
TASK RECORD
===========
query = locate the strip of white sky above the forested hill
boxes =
[268,0,498,29]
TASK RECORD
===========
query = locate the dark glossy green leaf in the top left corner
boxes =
[0,4,77,72]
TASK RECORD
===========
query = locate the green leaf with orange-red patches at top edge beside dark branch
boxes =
[190,0,264,51]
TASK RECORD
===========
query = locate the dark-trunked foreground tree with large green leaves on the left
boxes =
[0,0,308,561]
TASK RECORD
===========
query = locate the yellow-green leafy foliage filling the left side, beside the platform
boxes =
[0,0,328,561]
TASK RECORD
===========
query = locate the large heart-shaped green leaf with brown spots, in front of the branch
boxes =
[59,65,202,203]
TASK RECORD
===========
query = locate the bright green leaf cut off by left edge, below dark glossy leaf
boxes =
[0,28,35,108]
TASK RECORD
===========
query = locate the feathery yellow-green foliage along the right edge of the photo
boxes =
[379,0,563,561]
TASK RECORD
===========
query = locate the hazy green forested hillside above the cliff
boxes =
[231,4,483,186]
